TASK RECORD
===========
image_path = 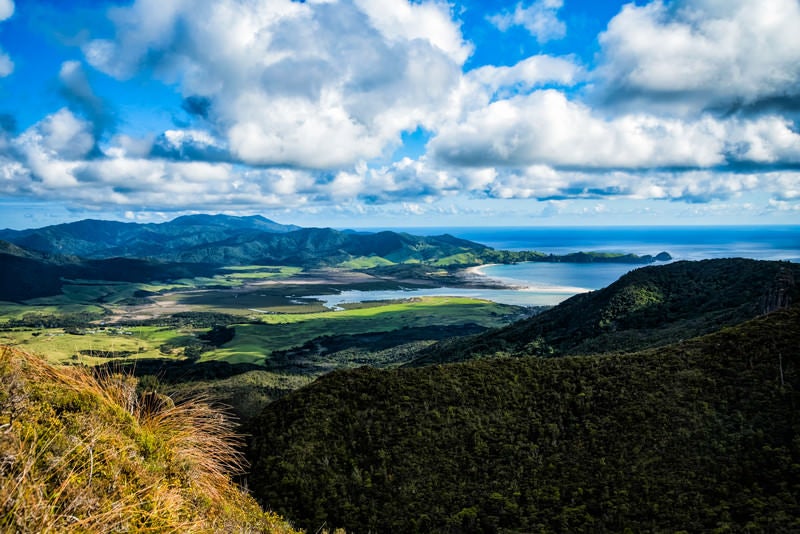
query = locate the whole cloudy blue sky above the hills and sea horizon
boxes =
[0,0,800,229]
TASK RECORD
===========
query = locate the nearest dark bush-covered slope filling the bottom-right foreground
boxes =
[249,305,800,532]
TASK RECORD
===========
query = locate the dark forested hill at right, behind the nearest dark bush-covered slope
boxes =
[413,258,800,365]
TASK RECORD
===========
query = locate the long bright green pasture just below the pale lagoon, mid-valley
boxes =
[203,297,517,363]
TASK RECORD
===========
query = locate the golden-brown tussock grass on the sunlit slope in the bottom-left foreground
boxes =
[0,348,294,532]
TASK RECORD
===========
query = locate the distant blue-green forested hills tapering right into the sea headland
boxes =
[0,215,670,268]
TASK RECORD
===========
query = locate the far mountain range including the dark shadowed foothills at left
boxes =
[0,215,670,301]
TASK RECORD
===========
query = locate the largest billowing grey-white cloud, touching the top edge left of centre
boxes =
[84,0,471,169]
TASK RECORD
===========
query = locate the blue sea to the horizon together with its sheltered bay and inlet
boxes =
[318,226,800,307]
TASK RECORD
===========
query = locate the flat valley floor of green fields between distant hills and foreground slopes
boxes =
[0,268,520,414]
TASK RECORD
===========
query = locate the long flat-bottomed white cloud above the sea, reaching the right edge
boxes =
[429,89,800,169]
